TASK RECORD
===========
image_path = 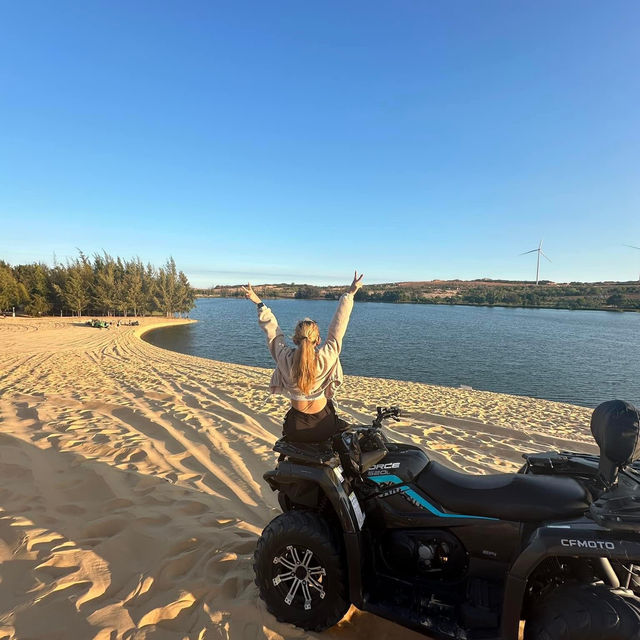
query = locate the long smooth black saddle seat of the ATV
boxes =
[415,462,591,522]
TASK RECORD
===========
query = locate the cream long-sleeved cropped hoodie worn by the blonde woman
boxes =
[258,292,353,399]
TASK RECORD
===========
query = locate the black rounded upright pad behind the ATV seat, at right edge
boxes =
[591,400,640,487]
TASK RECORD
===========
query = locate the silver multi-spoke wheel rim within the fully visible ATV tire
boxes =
[271,545,327,611]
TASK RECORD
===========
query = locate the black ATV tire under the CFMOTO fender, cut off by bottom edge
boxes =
[524,584,640,640]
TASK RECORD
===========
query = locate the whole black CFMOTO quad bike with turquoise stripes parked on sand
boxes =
[254,400,640,640]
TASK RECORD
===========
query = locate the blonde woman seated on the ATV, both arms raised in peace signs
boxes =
[242,271,363,442]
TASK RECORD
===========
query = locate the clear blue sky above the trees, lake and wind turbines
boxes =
[0,0,640,286]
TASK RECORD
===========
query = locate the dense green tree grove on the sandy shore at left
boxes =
[0,251,195,317]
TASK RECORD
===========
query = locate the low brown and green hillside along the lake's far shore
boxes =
[195,279,640,311]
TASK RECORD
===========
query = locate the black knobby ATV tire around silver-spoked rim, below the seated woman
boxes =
[253,510,350,631]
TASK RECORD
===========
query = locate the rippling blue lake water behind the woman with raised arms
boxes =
[145,298,640,407]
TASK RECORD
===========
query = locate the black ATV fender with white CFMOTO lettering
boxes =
[501,520,640,640]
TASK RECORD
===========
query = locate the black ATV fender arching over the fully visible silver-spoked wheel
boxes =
[263,461,363,607]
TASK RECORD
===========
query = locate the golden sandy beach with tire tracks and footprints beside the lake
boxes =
[0,318,595,640]
